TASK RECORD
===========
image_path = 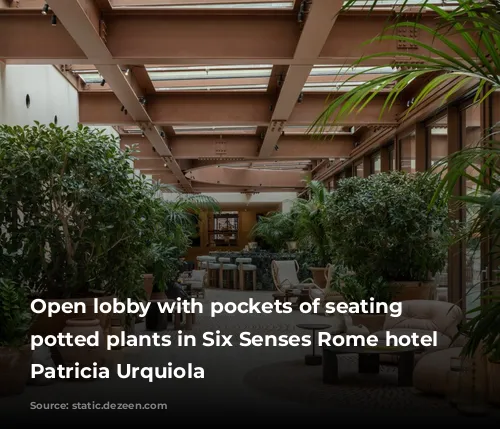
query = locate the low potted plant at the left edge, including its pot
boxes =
[0,278,33,396]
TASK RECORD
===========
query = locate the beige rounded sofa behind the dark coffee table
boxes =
[373,300,463,361]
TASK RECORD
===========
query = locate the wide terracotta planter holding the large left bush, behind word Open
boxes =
[30,296,113,336]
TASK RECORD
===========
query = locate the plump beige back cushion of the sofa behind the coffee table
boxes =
[384,300,463,338]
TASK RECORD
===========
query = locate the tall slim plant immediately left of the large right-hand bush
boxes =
[292,181,331,288]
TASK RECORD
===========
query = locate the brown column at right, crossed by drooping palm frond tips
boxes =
[447,106,465,309]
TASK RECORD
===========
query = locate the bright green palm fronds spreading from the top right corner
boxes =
[313,0,500,133]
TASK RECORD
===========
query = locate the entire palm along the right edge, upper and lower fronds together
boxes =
[312,0,500,361]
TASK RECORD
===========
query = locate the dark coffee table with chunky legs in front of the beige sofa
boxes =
[323,343,421,386]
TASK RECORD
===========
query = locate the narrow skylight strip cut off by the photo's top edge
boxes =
[108,0,293,9]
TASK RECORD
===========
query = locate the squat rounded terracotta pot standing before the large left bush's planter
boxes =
[57,317,105,367]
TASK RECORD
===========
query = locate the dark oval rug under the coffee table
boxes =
[244,355,456,414]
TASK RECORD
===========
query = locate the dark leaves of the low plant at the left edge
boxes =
[0,278,33,347]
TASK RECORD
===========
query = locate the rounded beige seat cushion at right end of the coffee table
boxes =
[413,347,462,395]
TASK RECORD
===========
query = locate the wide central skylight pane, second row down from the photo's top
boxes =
[146,65,272,91]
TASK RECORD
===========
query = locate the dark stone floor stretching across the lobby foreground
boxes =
[0,290,496,424]
